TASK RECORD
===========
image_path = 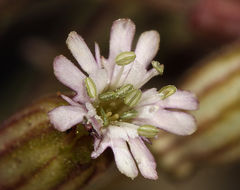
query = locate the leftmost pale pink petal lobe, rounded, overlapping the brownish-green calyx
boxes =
[48,106,86,131]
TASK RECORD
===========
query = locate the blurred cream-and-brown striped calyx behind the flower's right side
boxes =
[153,43,240,177]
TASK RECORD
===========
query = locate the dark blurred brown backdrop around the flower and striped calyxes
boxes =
[0,0,240,190]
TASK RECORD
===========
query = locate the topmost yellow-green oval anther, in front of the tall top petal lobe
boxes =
[115,51,136,66]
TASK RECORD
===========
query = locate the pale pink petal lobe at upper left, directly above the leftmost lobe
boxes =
[53,55,88,102]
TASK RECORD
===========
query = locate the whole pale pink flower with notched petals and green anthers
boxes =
[49,19,198,179]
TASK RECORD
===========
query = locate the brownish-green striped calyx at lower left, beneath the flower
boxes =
[0,96,111,190]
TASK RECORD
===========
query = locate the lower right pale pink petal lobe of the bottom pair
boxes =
[128,138,158,179]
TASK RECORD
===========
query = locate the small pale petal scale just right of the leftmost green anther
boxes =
[89,69,108,94]
